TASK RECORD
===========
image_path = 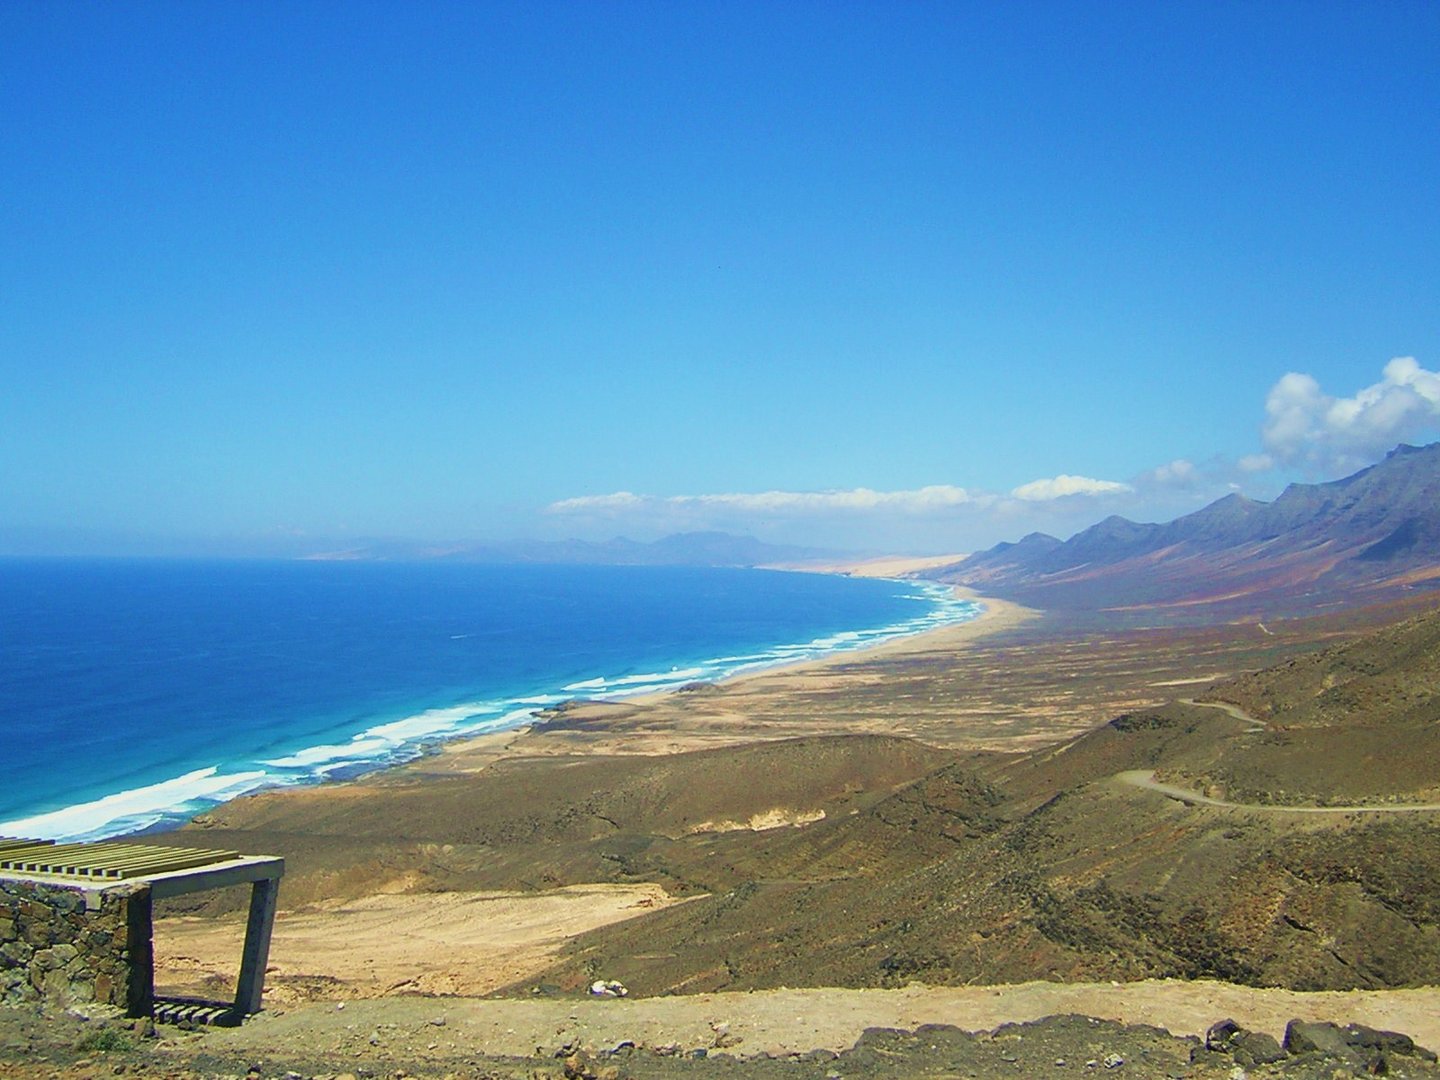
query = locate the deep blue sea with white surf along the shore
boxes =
[0,560,978,840]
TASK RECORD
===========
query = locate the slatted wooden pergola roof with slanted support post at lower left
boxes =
[0,837,285,1017]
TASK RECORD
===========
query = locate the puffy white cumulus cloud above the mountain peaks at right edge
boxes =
[1261,356,1440,469]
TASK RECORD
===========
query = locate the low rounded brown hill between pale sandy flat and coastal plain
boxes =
[156,736,952,914]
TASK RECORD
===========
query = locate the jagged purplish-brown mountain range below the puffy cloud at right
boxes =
[942,444,1440,618]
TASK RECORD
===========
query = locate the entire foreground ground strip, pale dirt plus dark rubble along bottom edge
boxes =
[0,982,1440,1080]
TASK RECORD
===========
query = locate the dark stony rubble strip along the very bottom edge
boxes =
[0,999,1440,1080]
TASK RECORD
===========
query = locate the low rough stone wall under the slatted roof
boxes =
[0,878,154,1017]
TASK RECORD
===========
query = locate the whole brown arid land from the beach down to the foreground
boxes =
[0,576,1440,1076]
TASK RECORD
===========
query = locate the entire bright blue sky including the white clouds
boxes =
[0,0,1440,553]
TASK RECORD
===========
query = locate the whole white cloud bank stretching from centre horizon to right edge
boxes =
[546,357,1440,547]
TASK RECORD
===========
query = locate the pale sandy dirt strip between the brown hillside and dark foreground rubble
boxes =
[182,981,1440,1057]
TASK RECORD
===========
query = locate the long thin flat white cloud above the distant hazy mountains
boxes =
[546,484,992,514]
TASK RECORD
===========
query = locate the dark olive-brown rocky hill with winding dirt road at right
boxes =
[521,612,1440,992]
